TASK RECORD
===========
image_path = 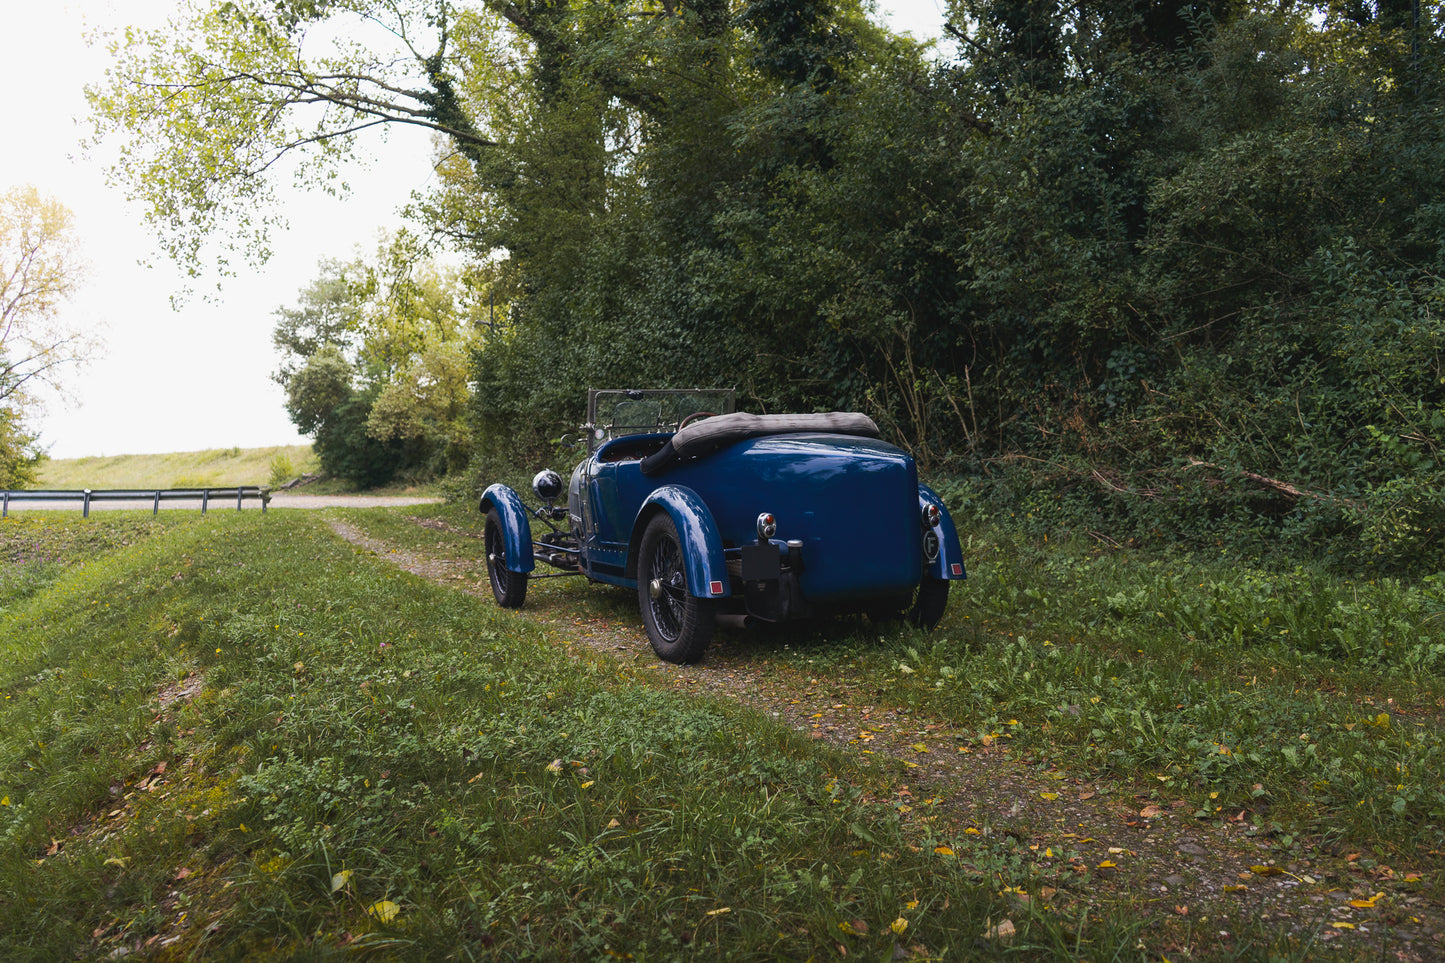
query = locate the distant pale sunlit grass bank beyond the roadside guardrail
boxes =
[36,445,319,490]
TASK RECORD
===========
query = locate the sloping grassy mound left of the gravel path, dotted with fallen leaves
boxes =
[0,515,1023,960]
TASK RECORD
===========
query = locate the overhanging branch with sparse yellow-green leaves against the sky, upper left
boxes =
[87,0,491,273]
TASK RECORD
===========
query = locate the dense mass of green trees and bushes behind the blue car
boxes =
[84,0,1445,574]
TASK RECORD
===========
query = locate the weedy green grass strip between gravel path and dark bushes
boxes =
[335,506,1445,856]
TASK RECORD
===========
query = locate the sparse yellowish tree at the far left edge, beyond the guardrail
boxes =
[0,187,91,486]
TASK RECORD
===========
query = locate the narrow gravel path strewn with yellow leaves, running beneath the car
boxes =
[329,519,1445,962]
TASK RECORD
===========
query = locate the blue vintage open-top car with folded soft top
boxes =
[481,390,964,664]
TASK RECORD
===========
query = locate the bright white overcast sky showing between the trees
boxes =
[0,0,944,458]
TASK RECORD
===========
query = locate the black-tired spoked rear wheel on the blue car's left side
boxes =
[637,515,717,665]
